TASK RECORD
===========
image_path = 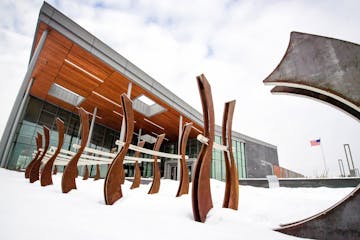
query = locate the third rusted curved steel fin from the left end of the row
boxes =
[40,118,64,187]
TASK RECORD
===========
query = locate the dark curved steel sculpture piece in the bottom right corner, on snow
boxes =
[275,185,360,239]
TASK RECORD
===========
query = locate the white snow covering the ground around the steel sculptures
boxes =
[0,169,353,240]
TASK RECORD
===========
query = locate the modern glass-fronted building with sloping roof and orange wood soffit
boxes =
[0,3,292,180]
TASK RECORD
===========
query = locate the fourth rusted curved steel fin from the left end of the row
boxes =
[61,108,89,193]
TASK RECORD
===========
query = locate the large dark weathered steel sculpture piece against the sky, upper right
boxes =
[263,32,360,121]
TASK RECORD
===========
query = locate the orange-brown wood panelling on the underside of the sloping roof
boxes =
[31,23,202,141]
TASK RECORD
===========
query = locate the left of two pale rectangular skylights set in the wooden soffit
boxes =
[48,83,85,106]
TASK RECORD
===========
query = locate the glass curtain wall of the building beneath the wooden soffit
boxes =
[7,96,246,181]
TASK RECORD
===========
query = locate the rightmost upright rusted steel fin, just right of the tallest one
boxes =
[222,101,239,210]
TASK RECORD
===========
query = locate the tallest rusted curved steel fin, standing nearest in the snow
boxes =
[192,74,215,222]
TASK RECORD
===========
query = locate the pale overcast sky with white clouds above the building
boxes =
[0,0,360,176]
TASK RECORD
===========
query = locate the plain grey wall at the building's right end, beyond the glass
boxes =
[245,141,279,178]
